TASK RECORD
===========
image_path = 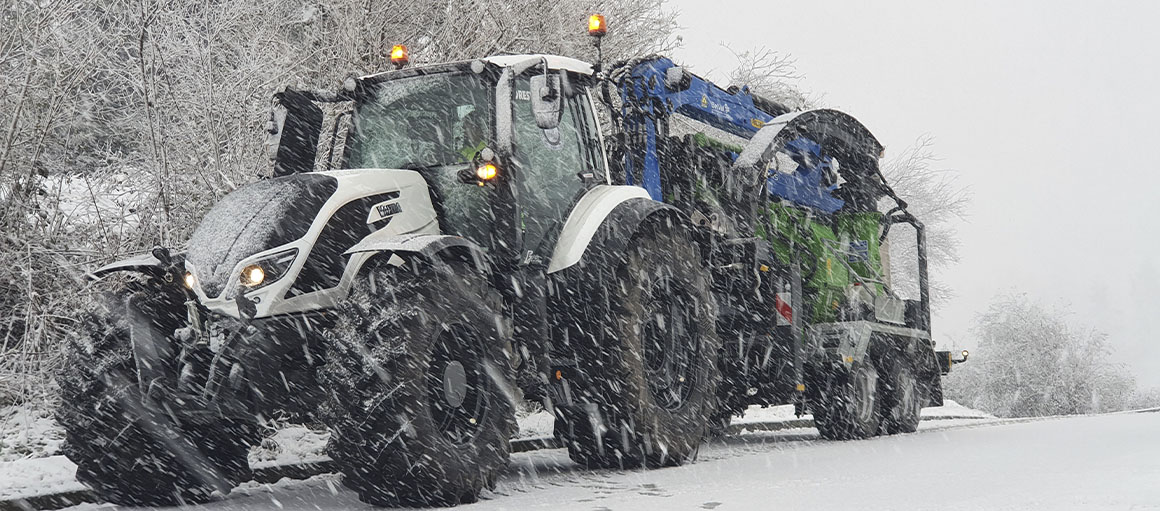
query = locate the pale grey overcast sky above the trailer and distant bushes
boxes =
[670,0,1160,386]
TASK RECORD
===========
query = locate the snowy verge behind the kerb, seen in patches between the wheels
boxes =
[0,401,992,501]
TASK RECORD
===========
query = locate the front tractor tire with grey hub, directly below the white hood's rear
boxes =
[320,258,515,506]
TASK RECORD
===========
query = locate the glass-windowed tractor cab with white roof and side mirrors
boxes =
[269,56,608,265]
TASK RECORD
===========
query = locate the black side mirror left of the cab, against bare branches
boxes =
[264,89,322,176]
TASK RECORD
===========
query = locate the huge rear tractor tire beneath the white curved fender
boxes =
[566,225,719,468]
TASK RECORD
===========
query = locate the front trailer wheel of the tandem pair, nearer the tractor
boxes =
[812,359,882,440]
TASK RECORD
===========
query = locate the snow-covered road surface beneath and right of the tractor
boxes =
[63,413,1160,511]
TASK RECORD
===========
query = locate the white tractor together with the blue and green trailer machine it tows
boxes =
[57,17,960,506]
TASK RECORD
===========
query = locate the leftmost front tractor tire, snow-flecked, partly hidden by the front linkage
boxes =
[56,287,258,506]
